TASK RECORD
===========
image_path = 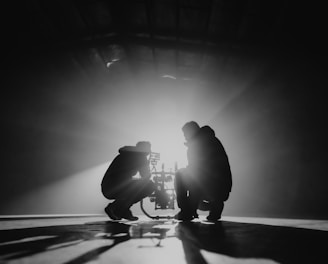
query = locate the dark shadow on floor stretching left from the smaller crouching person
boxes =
[0,222,130,263]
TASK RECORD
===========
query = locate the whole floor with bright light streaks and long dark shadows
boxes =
[0,215,328,264]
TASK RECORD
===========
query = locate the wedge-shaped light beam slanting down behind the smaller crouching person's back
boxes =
[3,162,110,214]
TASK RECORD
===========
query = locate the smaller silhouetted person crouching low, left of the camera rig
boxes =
[101,141,155,220]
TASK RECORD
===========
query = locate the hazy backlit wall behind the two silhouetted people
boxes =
[0,0,328,219]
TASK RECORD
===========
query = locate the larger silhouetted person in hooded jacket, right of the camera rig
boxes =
[175,121,232,221]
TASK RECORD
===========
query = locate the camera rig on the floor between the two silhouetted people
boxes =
[140,152,178,219]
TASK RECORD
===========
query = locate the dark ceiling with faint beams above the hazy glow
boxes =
[6,0,319,82]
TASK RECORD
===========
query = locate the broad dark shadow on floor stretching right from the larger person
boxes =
[176,221,328,264]
